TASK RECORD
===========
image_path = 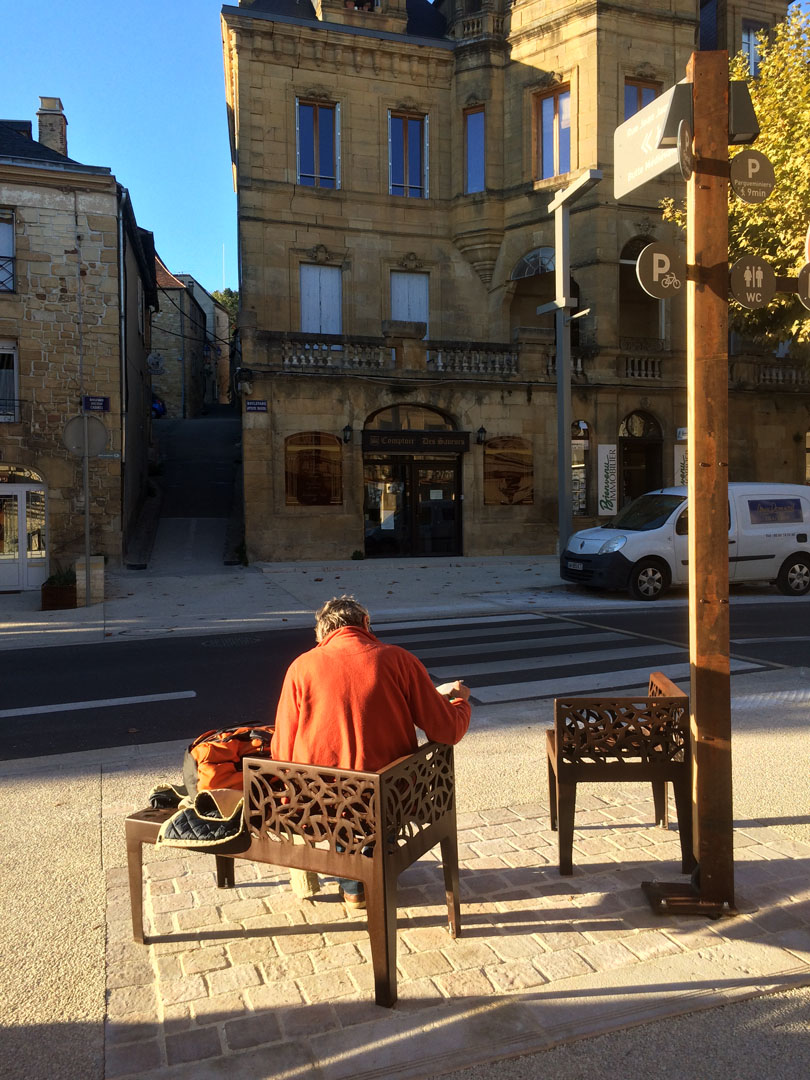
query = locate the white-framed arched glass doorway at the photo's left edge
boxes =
[0,463,48,592]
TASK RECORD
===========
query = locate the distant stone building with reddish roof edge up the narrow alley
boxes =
[149,257,211,420]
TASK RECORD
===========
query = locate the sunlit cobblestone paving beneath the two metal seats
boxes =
[105,795,810,1080]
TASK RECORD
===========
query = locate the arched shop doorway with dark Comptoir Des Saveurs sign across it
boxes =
[363,404,463,558]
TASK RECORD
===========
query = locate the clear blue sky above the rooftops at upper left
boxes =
[9,0,239,289]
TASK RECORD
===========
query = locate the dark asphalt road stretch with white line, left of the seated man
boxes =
[0,630,314,760]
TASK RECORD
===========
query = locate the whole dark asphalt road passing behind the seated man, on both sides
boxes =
[0,599,810,759]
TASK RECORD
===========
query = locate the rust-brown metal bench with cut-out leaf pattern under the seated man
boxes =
[126,743,460,1005]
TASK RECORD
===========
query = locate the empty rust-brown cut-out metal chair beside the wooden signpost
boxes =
[545,672,694,874]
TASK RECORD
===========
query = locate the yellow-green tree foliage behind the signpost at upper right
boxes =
[662,5,810,342]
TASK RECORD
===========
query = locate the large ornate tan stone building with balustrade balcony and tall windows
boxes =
[217,0,810,559]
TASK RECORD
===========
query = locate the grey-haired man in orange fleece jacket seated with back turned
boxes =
[271,596,470,906]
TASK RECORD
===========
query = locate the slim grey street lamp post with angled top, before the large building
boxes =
[537,168,602,553]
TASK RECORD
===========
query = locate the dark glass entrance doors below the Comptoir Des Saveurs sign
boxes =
[363,457,461,558]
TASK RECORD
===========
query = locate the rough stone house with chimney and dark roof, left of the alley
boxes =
[0,97,157,591]
